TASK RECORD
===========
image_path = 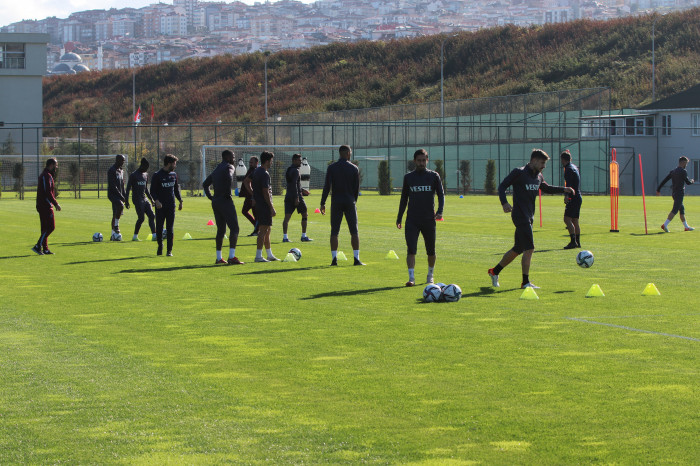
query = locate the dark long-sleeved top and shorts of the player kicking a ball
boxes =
[498,165,564,254]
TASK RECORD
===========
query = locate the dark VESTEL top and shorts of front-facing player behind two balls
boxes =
[396,170,445,256]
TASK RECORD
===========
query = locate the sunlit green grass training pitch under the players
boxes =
[0,193,700,464]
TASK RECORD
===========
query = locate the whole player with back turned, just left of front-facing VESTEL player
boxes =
[321,145,365,265]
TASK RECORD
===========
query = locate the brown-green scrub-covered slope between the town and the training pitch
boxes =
[44,8,700,123]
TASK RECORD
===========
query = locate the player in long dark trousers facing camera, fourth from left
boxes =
[151,154,182,256]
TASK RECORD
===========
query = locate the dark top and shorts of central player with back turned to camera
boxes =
[321,158,360,236]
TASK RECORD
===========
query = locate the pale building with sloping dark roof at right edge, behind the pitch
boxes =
[581,84,700,195]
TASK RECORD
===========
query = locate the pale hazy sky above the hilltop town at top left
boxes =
[0,0,312,26]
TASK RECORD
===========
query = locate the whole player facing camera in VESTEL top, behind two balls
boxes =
[396,149,445,286]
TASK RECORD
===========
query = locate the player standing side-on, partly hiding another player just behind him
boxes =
[251,151,279,262]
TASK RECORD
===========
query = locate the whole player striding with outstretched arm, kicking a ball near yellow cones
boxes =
[489,149,576,288]
